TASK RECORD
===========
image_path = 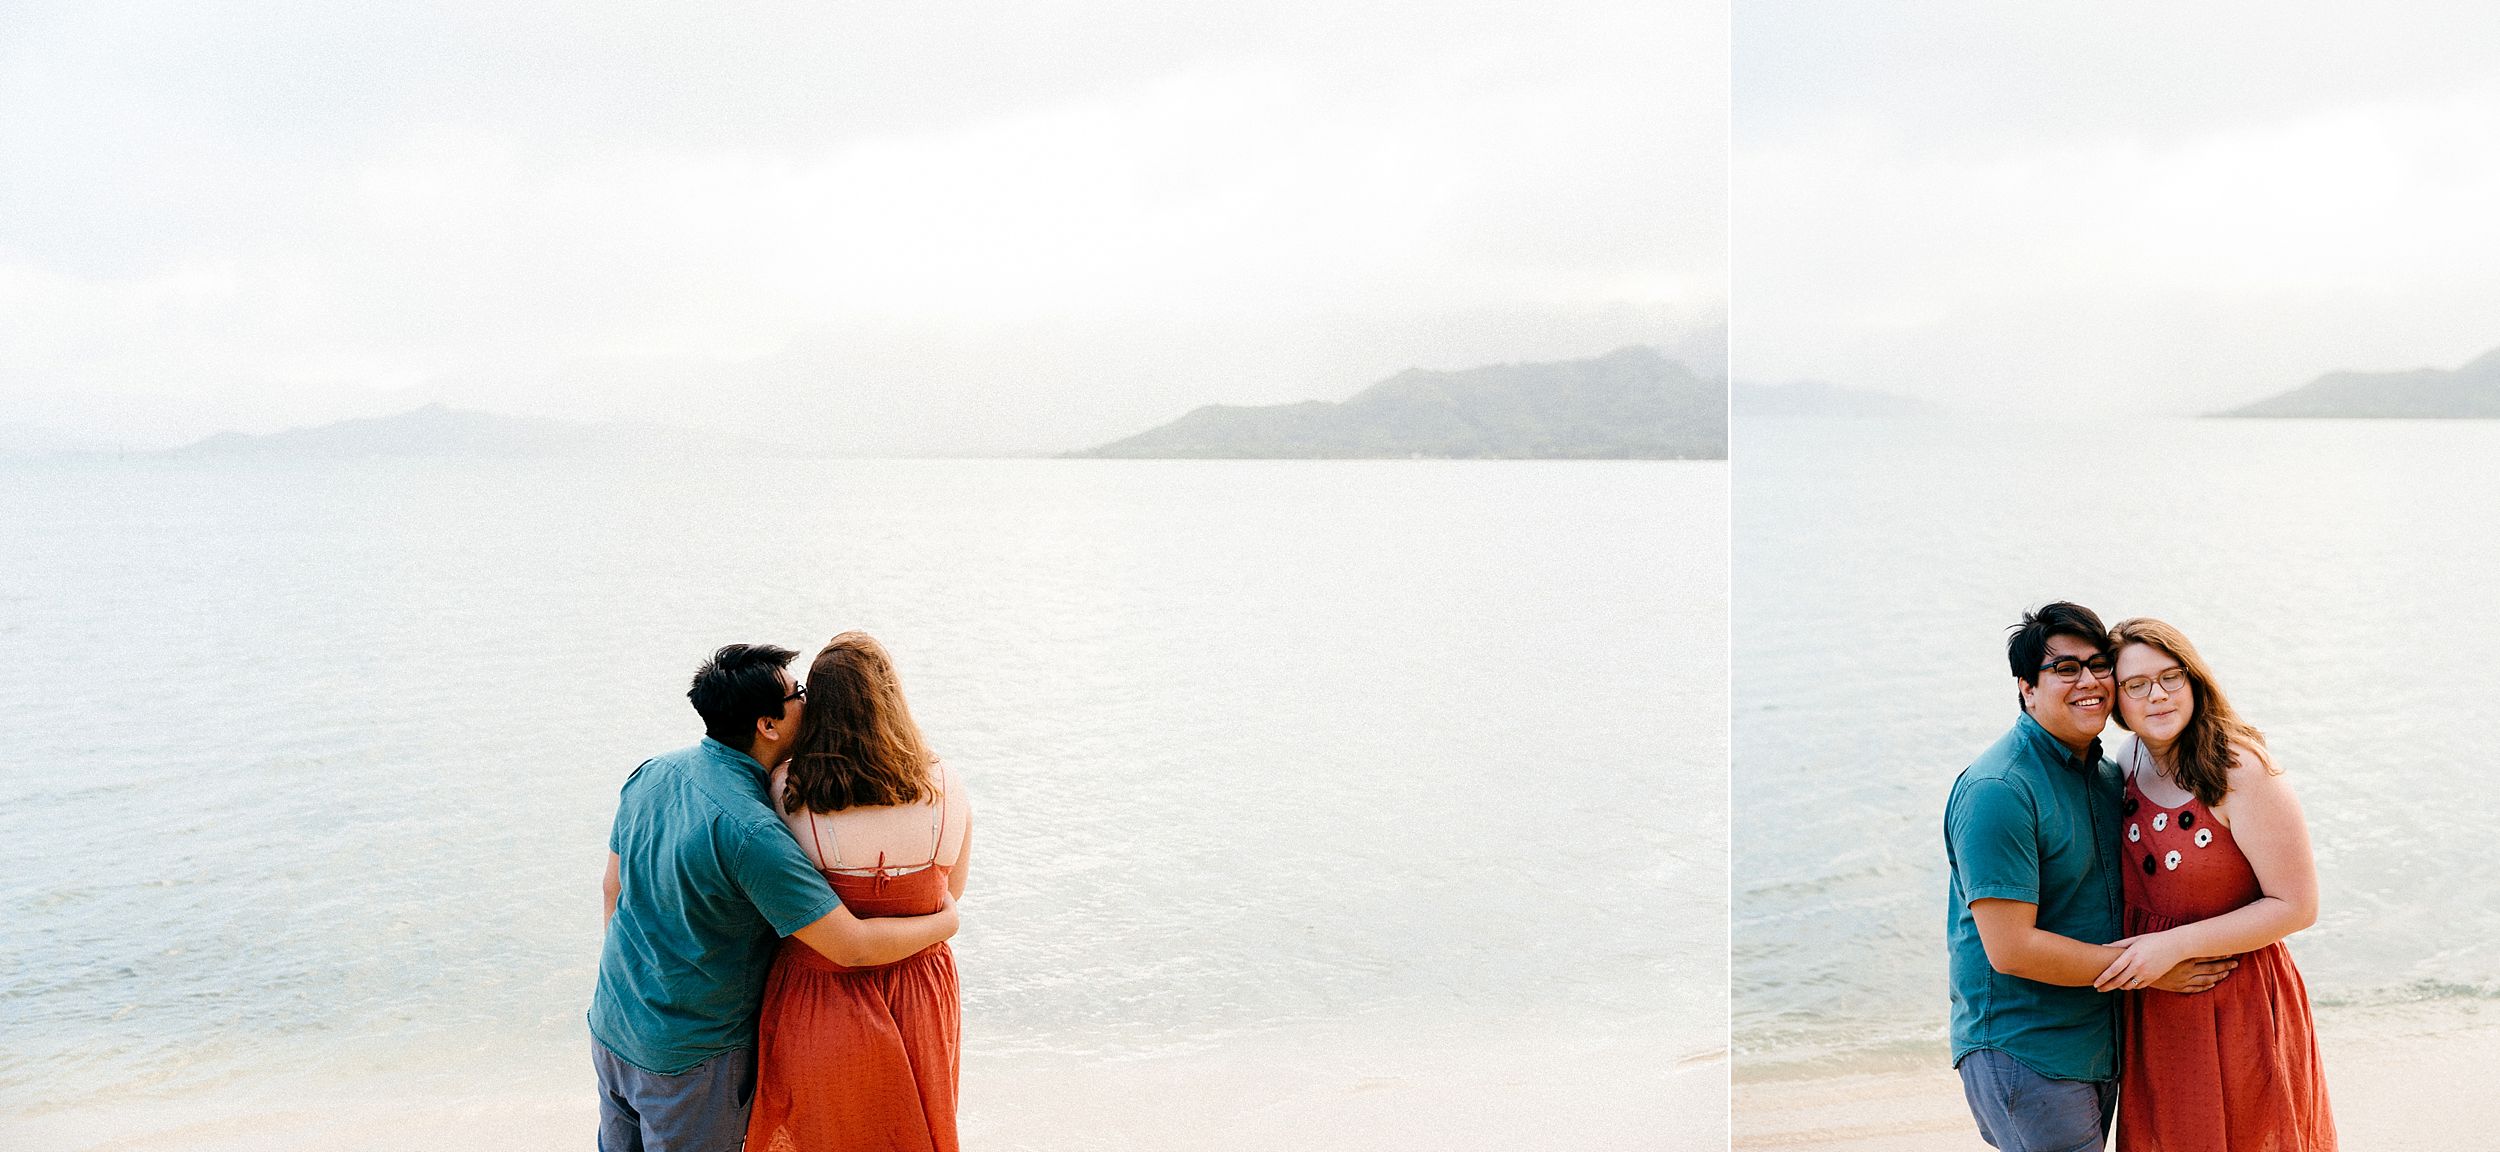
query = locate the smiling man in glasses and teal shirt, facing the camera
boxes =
[1945,602,2238,1152]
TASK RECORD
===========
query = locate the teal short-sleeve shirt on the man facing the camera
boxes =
[1945,715,2125,1080]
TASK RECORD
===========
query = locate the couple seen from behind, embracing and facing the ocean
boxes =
[590,632,973,1152]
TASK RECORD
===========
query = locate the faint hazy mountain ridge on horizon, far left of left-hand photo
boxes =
[165,405,818,457]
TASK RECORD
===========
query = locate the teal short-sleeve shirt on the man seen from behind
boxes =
[590,737,843,1075]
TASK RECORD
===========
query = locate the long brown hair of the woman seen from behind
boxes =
[783,632,938,815]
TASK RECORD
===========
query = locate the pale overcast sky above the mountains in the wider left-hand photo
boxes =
[0,0,1728,450]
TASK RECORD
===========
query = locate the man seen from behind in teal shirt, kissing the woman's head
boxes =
[590,645,955,1152]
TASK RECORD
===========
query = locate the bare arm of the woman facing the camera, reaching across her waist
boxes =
[2093,747,2318,992]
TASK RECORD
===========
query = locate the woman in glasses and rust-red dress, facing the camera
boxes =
[2095,620,2335,1152]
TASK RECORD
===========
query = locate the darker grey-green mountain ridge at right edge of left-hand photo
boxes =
[1070,345,1728,460]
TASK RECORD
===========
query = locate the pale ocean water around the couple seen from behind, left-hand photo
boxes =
[0,460,1728,1115]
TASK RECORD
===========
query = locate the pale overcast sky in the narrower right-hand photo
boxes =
[1730,0,2500,412]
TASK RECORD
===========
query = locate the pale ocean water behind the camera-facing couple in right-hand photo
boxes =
[1733,420,2500,1077]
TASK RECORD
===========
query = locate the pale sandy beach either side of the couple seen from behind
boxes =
[0,1032,1728,1152]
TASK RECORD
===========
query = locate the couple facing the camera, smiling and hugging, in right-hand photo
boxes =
[1945,602,2335,1152]
